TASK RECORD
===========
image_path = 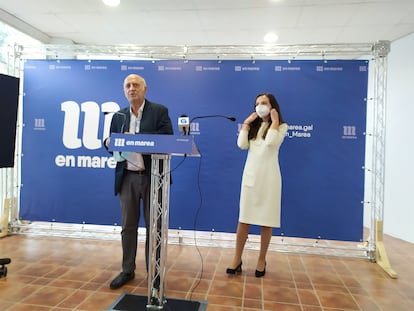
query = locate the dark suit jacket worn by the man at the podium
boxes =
[104,99,173,195]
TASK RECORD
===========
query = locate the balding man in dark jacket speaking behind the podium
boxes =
[105,74,173,289]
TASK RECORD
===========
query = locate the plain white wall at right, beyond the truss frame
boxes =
[384,33,414,243]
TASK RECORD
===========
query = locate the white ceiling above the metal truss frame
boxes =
[0,0,414,46]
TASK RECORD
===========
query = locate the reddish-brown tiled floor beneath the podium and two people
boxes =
[0,235,414,311]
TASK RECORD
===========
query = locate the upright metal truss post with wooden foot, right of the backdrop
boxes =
[370,41,397,278]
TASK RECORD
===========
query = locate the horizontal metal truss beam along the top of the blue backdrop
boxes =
[15,43,375,59]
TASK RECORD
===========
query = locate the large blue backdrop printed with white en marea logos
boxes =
[20,60,368,241]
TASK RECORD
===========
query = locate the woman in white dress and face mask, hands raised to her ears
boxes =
[226,93,288,277]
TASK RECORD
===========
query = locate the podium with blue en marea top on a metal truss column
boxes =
[109,133,200,310]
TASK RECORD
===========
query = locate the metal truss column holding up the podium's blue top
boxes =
[147,154,171,310]
